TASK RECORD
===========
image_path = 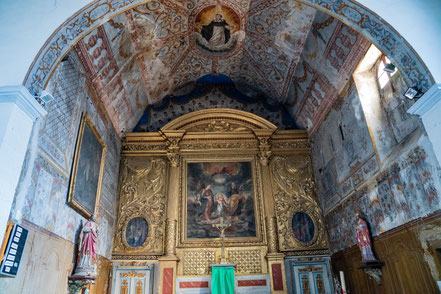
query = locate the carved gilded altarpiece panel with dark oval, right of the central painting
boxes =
[271,155,327,251]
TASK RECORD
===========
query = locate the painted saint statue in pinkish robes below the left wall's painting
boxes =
[74,215,98,277]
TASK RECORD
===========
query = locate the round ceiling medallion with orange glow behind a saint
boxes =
[194,5,244,54]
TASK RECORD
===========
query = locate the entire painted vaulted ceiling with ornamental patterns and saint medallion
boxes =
[71,0,368,131]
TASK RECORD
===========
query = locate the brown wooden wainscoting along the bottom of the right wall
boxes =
[331,212,441,294]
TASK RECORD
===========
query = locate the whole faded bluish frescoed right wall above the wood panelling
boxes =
[312,68,441,252]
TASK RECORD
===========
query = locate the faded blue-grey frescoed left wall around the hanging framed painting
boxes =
[10,54,121,258]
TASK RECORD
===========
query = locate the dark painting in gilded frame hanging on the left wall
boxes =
[68,113,106,218]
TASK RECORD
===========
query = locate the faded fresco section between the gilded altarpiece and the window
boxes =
[312,85,378,209]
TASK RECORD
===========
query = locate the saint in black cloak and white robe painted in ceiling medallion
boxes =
[201,14,234,46]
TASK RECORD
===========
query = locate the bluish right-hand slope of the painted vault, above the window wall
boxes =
[286,11,370,134]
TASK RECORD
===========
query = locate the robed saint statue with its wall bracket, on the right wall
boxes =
[355,210,384,285]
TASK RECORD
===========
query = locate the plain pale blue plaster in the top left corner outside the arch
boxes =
[0,0,90,86]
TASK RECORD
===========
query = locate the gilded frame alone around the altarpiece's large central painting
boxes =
[178,154,266,247]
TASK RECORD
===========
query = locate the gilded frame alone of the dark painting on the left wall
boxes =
[68,113,107,218]
